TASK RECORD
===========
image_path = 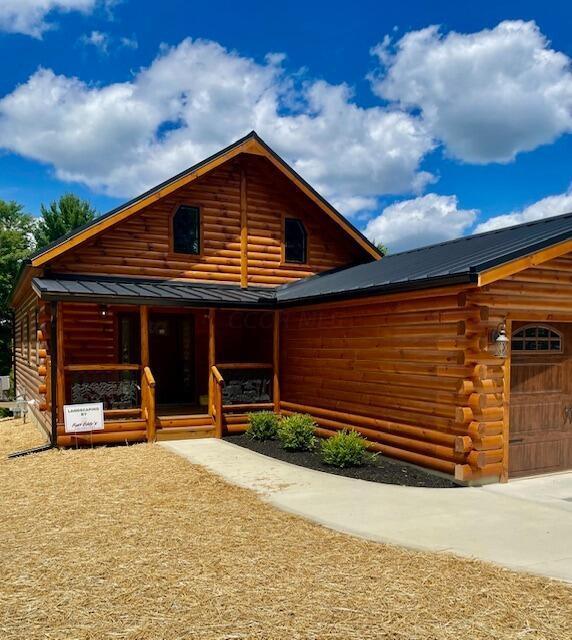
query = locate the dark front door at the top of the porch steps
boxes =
[149,313,197,405]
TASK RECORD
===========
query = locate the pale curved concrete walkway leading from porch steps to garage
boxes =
[161,438,572,582]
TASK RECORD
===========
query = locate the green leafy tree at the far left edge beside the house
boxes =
[0,200,34,375]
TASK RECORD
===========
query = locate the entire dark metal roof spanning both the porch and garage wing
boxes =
[32,213,572,308]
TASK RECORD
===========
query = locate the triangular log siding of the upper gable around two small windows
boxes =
[50,156,365,285]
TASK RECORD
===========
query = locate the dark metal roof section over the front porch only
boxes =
[32,275,276,308]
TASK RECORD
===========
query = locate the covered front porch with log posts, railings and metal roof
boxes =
[35,279,280,446]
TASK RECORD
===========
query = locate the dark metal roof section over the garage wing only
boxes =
[277,213,572,304]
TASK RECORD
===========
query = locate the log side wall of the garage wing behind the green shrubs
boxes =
[280,295,503,480]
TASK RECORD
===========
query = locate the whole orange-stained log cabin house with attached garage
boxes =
[7,132,572,484]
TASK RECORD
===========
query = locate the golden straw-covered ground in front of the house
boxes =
[0,421,572,640]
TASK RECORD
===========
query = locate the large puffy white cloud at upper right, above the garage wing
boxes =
[371,20,572,163]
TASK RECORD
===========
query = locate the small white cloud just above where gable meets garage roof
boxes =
[365,193,478,252]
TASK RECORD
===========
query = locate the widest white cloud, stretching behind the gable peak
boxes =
[0,39,433,214]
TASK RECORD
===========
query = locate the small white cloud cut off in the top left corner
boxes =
[0,0,100,38]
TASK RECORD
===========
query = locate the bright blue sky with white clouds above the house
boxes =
[0,0,572,251]
